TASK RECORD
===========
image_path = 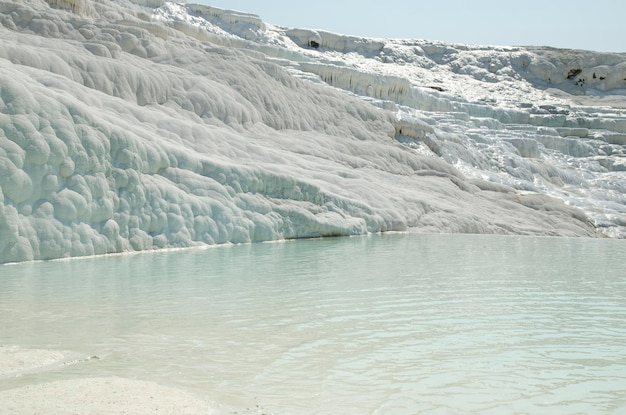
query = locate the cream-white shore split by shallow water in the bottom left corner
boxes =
[0,346,214,415]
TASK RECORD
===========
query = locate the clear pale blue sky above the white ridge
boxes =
[195,0,626,52]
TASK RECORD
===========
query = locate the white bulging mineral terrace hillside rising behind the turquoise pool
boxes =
[0,0,626,263]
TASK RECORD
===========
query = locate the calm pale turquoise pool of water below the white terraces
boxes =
[0,235,626,415]
